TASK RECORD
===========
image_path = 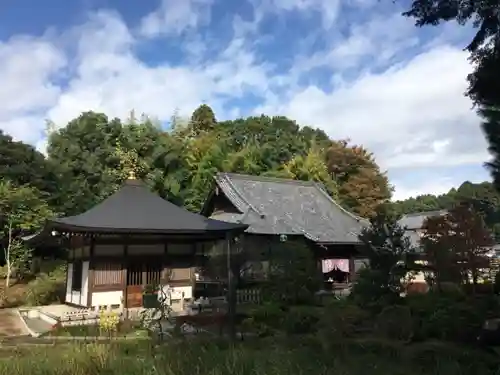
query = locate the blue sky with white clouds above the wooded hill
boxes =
[0,0,489,199]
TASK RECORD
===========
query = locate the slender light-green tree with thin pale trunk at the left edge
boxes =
[0,180,53,287]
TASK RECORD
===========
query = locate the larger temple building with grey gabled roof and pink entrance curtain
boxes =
[201,173,370,286]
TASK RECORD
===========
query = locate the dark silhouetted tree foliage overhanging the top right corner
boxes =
[403,0,500,189]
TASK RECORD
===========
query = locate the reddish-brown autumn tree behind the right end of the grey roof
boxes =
[326,141,392,217]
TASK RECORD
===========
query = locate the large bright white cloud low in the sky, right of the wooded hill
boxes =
[262,46,487,168]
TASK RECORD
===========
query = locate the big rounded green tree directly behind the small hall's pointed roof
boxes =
[48,112,176,215]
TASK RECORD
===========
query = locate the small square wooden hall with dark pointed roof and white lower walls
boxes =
[31,175,247,308]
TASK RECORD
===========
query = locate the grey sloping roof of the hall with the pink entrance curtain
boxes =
[205,173,369,244]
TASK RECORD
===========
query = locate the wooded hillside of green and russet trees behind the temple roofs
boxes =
[0,105,391,220]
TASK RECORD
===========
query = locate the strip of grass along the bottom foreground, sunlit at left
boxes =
[0,338,499,375]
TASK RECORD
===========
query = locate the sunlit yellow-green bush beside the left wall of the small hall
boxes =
[25,266,66,306]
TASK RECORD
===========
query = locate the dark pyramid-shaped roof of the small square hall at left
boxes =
[47,180,247,234]
